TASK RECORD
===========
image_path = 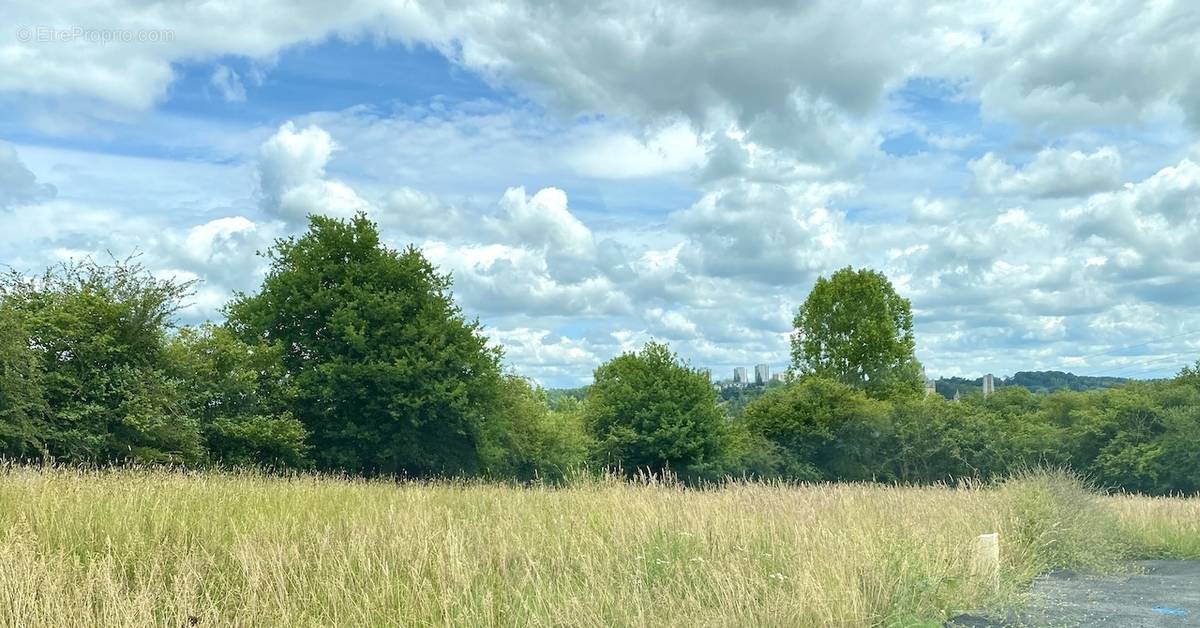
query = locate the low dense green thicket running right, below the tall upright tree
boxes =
[734,370,1200,495]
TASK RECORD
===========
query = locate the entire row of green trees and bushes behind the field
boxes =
[0,216,1200,494]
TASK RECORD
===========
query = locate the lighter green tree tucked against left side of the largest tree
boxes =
[170,324,308,467]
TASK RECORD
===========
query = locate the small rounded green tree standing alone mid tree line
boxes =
[584,342,726,479]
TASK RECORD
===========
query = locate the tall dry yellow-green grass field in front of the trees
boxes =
[0,467,1200,627]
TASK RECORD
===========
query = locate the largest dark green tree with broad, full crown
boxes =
[227,215,500,476]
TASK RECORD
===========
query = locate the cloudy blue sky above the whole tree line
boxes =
[0,0,1200,387]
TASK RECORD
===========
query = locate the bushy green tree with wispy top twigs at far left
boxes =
[2,261,204,463]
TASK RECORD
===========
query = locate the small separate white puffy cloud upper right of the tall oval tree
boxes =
[967,146,1121,198]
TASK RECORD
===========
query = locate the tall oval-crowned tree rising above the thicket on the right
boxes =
[792,267,922,397]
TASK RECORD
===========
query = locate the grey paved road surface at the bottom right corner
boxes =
[947,561,1200,628]
